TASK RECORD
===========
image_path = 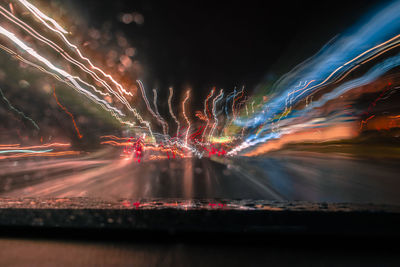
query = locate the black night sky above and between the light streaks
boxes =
[65,0,382,108]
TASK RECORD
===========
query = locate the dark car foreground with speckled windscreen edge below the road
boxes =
[0,198,400,266]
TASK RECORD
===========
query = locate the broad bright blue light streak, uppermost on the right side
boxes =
[237,1,400,133]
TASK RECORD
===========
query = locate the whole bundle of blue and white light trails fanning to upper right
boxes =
[231,1,400,154]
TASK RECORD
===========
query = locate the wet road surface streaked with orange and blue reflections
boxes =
[0,153,400,204]
